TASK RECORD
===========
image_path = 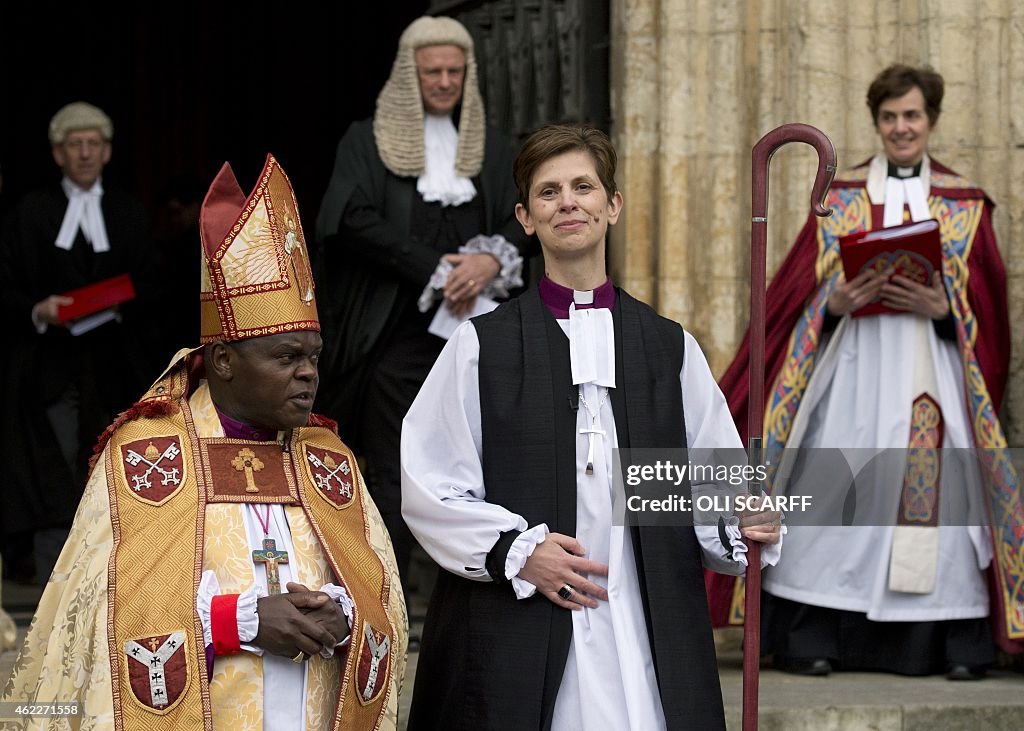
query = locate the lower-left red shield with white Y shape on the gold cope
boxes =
[125,631,188,715]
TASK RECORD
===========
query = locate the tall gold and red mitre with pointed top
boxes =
[200,155,319,343]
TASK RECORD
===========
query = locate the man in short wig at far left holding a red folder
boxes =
[0,101,155,584]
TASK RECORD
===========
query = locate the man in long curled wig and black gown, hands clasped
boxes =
[316,16,526,593]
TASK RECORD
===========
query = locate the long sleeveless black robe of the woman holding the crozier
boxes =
[409,289,725,730]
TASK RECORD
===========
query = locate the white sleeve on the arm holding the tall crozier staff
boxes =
[679,331,786,575]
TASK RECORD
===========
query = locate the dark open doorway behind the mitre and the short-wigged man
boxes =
[0,0,428,229]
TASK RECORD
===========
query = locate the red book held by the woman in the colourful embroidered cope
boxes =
[839,218,942,317]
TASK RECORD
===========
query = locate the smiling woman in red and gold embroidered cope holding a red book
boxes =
[712,66,1024,679]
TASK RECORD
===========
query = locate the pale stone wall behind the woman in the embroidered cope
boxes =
[611,0,1024,446]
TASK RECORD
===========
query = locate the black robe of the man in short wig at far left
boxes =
[0,183,155,533]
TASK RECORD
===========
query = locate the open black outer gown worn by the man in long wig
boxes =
[314,114,536,449]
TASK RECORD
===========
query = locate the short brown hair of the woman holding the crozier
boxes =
[512,124,618,206]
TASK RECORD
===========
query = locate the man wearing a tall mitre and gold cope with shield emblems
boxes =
[4,152,407,731]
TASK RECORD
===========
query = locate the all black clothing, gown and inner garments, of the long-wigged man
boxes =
[316,115,526,577]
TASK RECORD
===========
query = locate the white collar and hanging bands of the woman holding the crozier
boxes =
[568,290,615,388]
